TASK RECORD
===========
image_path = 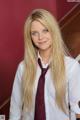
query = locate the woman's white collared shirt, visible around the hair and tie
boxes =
[9,57,80,120]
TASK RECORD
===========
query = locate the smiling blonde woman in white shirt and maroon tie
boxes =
[9,9,80,120]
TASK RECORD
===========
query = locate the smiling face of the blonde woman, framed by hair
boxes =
[31,20,52,51]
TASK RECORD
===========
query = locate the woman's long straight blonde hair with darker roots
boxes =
[23,9,66,112]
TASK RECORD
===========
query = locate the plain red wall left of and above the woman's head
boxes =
[0,0,57,118]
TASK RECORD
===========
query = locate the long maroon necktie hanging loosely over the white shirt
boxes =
[34,59,49,120]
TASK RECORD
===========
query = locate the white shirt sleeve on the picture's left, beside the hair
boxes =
[9,63,23,120]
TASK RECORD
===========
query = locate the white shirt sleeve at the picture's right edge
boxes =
[69,60,80,114]
